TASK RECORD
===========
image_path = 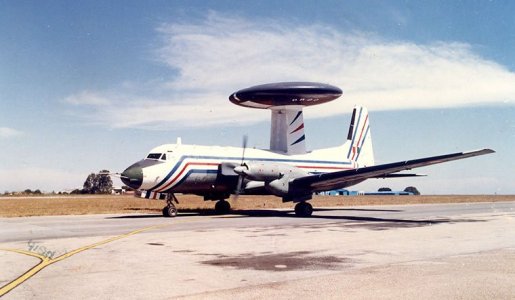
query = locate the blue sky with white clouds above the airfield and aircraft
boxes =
[0,1,515,194]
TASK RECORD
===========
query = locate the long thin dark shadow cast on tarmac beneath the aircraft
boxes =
[108,208,485,230]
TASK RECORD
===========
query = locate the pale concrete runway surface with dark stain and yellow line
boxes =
[0,202,515,299]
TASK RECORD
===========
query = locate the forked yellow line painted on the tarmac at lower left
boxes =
[0,220,204,297]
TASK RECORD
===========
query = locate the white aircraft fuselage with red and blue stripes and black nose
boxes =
[122,144,357,197]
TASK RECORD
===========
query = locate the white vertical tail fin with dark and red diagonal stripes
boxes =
[345,106,374,167]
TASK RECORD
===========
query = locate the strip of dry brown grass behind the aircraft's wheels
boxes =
[0,195,515,217]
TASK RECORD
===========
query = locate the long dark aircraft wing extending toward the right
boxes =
[290,149,495,192]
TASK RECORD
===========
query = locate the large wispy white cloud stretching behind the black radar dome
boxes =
[66,13,515,129]
